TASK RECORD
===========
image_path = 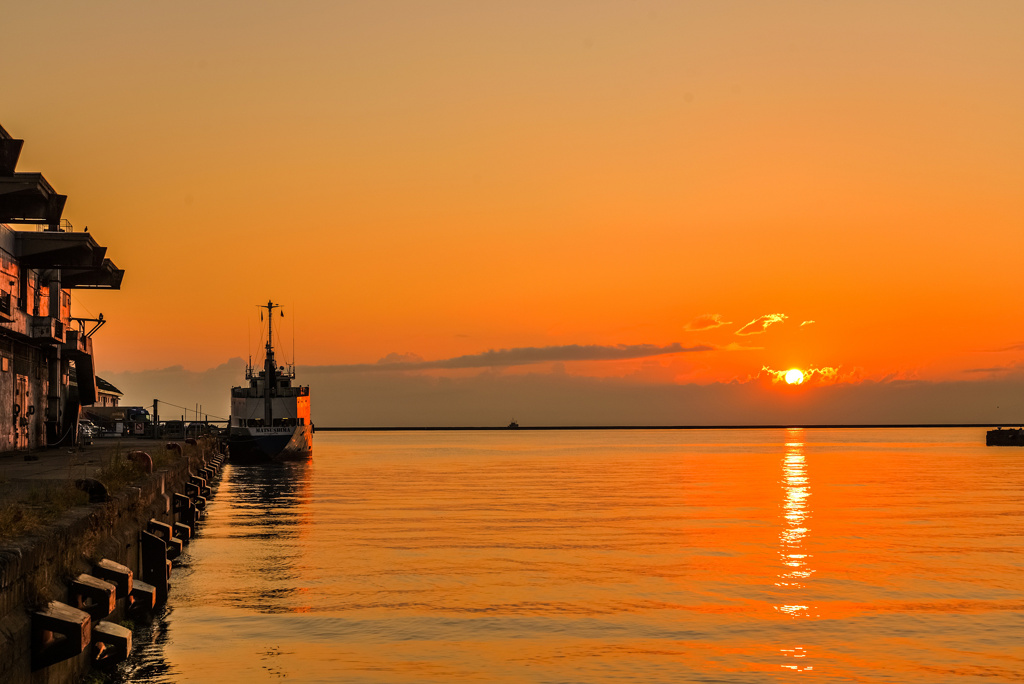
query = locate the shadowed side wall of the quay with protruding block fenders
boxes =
[0,440,222,684]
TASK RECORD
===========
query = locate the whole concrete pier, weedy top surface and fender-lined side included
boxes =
[0,438,221,684]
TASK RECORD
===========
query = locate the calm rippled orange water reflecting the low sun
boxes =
[116,429,1024,683]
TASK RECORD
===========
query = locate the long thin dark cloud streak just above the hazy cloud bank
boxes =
[317,342,716,373]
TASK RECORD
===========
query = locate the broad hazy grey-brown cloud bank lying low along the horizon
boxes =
[99,358,1024,428]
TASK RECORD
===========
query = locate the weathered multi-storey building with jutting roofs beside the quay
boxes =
[0,127,124,452]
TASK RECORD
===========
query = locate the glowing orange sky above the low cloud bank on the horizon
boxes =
[0,0,1024,411]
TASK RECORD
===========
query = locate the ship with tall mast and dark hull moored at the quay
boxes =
[227,301,313,463]
